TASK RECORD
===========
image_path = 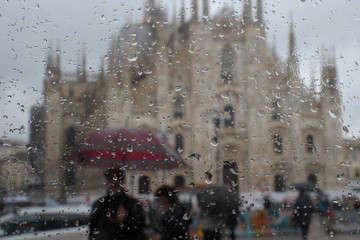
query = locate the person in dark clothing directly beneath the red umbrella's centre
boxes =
[89,166,146,240]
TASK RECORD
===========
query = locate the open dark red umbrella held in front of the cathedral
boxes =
[69,128,184,170]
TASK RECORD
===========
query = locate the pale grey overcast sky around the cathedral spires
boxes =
[0,0,360,142]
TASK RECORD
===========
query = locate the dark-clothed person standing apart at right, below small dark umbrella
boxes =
[293,189,314,240]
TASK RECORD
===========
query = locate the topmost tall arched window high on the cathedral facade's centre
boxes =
[221,45,236,83]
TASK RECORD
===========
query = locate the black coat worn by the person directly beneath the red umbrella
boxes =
[89,191,146,240]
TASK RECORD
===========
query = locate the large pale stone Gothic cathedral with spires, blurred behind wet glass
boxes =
[44,0,352,197]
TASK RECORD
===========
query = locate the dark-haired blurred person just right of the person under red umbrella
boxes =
[151,185,191,240]
